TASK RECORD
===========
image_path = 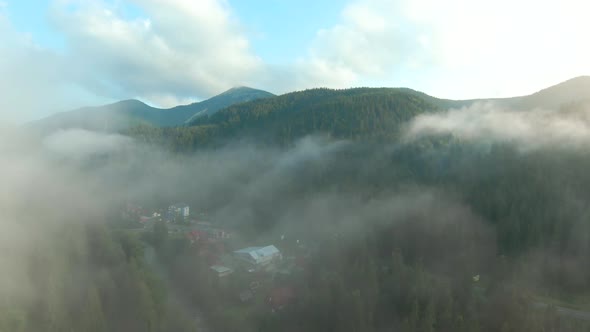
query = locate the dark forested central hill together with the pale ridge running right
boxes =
[130,77,590,150]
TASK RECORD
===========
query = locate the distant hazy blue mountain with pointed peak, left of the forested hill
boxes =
[28,87,274,131]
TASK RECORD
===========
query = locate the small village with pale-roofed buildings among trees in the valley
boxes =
[124,203,310,313]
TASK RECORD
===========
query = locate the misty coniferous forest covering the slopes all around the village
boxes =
[0,83,590,332]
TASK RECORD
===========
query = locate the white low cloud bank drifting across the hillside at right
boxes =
[406,103,590,150]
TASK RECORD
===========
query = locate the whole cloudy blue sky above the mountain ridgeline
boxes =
[0,0,590,123]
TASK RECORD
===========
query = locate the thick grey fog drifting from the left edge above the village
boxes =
[0,129,490,293]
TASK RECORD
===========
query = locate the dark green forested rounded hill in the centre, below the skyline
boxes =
[192,88,462,142]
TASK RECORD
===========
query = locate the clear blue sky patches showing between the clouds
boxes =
[4,0,346,59]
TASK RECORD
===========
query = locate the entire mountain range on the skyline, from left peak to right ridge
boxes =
[28,76,590,143]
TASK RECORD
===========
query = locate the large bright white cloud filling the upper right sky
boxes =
[300,0,590,98]
